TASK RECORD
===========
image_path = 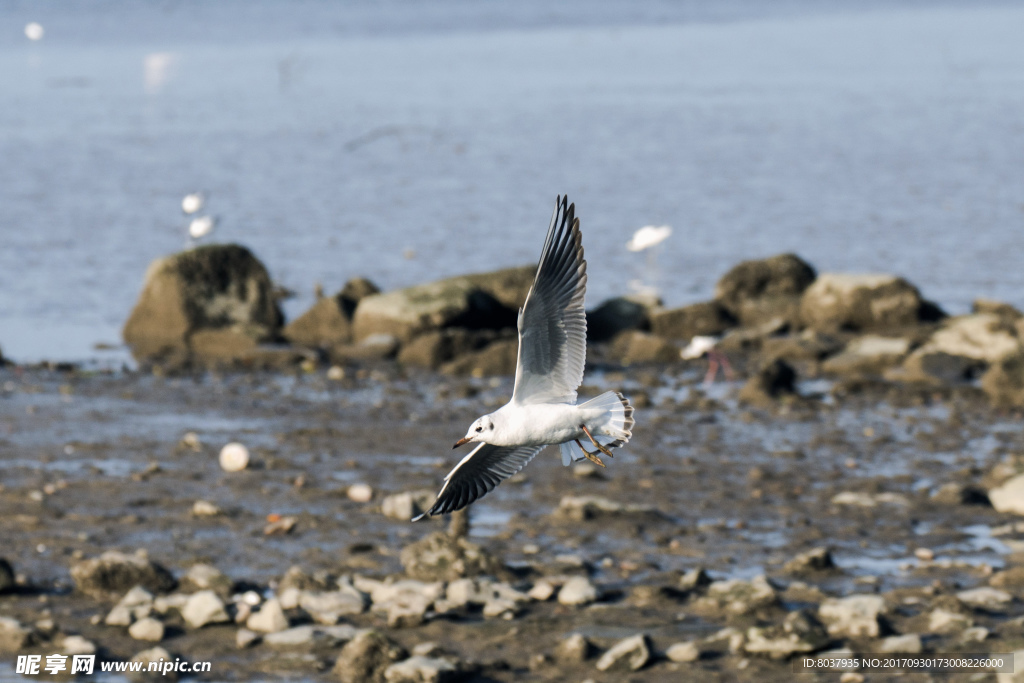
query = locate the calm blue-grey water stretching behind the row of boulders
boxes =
[0,0,1024,360]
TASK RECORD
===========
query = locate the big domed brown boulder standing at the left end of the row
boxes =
[123,245,283,362]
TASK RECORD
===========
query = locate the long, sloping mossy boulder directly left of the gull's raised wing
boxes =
[352,266,535,343]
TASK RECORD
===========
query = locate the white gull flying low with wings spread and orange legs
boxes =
[413,197,634,521]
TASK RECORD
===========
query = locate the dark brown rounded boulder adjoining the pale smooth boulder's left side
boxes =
[715,254,816,328]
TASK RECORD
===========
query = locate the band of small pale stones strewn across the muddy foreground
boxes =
[6,535,1024,683]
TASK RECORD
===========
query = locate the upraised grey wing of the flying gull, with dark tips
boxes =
[512,197,587,403]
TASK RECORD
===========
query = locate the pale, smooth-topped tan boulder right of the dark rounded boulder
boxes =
[800,272,944,332]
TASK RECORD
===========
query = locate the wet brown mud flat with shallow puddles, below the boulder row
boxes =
[0,361,1024,681]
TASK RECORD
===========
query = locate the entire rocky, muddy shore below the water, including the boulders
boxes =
[6,245,1024,682]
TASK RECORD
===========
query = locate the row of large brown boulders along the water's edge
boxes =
[117,245,1024,405]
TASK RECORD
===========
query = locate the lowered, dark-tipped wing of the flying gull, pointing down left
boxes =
[413,443,544,522]
